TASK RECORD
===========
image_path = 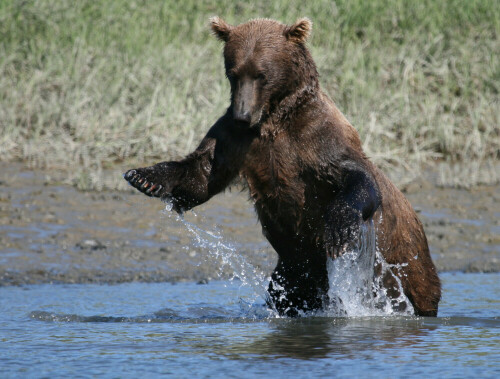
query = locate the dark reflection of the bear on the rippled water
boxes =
[223,318,436,360]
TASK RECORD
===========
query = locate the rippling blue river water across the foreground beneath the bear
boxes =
[0,273,500,378]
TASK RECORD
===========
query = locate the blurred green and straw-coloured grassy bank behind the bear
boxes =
[0,0,500,189]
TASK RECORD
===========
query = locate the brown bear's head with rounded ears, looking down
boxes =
[211,17,318,127]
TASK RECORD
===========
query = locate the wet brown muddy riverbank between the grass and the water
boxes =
[0,164,500,285]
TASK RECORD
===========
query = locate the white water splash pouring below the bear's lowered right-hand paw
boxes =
[324,221,414,317]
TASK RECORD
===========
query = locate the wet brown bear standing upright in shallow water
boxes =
[124,17,441,316]
